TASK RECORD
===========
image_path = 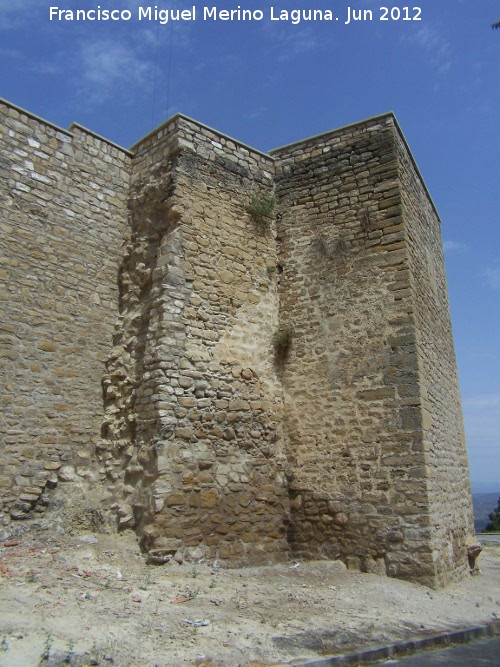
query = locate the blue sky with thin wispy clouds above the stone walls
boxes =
[0,0,500,493]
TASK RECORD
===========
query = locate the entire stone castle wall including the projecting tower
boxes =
[0,98,471,585]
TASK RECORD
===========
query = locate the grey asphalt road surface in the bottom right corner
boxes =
[378,637,500,667]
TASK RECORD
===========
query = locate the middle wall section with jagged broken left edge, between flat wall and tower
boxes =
[96,119,288,564]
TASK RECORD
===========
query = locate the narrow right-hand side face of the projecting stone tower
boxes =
[396,129,473,583]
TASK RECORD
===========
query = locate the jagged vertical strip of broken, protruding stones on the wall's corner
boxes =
[98,146,182,528]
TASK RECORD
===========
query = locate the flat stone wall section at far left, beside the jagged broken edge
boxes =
[0,102,130,516]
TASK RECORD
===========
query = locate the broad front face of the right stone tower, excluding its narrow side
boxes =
[273,116,432,578]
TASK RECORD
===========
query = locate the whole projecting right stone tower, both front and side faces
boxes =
[272,114,473,585]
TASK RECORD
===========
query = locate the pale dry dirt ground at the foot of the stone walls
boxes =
[0,531,500,667]
